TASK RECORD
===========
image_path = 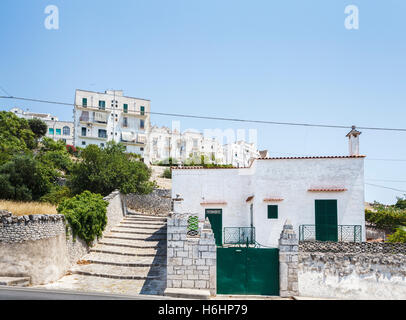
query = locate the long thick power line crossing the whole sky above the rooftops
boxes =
[0,96,406,132]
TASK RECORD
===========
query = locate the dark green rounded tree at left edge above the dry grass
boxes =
[0,155,58,201]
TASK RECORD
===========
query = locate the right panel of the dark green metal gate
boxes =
[246,248,279,296]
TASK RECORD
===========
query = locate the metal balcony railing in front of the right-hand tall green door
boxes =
[299,224,362,242]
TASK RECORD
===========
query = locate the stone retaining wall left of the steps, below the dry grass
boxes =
[0,191,126,285]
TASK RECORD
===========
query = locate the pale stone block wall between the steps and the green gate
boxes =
[167,214,217,295]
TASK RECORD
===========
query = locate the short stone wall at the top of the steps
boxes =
[126,189,172,215]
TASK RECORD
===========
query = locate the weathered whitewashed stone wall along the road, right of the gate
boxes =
[298,242,406,299]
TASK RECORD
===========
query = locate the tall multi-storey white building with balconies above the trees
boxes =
[74,90,151,162]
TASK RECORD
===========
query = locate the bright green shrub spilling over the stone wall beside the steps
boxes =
[57,191,108,245]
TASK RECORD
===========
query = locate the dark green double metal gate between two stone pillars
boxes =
[217,247,279,296]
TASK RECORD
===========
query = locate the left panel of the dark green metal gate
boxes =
[217,248,246,294]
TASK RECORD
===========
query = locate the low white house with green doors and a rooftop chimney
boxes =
[172,127,365,247]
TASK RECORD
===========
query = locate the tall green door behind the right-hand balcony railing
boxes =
[315,200,338,241]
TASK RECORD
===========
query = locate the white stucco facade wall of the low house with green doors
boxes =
[172,157,365,246]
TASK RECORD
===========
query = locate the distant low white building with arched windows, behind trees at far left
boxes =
[9,107,73,145]
